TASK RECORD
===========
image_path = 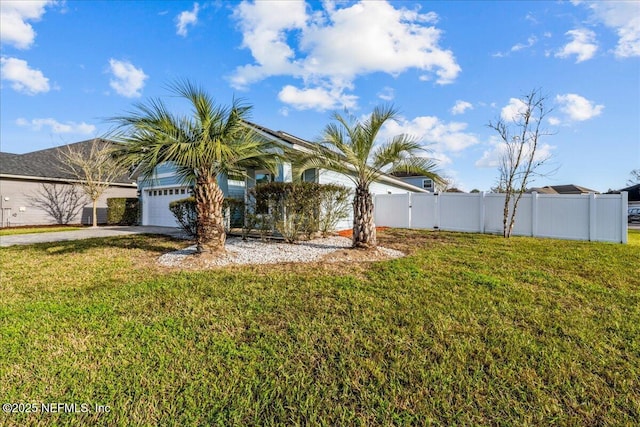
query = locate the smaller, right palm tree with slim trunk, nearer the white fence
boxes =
[298,105,443,248]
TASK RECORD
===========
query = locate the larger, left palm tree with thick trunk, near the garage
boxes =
[111,80,278,254]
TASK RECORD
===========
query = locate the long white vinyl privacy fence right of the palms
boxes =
[374,192,627,243]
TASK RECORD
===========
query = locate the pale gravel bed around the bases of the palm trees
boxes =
[158,236,404,267]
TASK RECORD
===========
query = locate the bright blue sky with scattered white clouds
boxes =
[0,0,640,191]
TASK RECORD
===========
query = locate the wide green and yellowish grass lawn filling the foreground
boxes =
[0,229,640,426]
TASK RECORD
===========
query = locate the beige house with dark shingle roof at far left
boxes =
[0,139,137,227]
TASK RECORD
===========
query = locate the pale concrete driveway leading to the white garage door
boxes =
[0,226,188,246]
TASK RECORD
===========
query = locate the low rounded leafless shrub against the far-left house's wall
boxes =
[29,184,84,225]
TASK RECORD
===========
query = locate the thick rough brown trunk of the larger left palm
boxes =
[193,173,227,254]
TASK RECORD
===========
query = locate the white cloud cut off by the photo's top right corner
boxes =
[583,1,640,58]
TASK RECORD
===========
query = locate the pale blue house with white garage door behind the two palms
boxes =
[138,123,425,229]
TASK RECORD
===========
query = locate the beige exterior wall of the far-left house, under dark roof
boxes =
[0,179,137,227]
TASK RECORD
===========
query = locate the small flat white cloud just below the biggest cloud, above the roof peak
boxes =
[278,85,358,111]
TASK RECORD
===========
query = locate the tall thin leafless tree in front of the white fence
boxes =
[488,89,553,237]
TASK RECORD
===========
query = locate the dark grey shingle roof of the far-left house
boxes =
[0,138,131,184]
